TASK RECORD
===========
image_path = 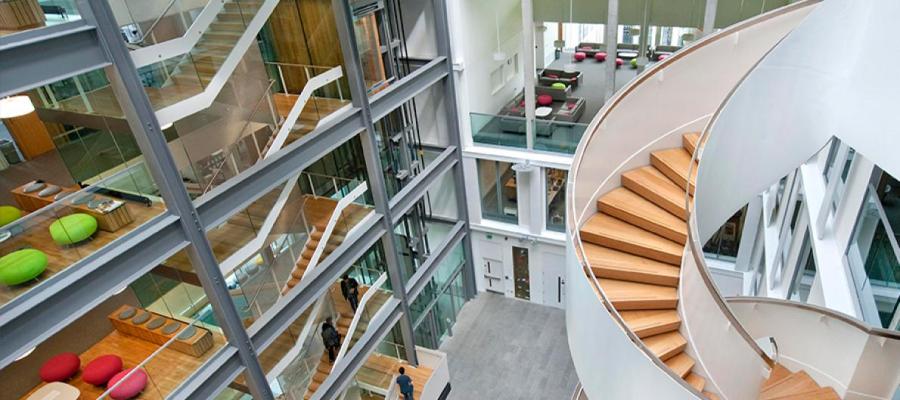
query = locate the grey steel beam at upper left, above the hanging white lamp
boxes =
[0,20,110,97]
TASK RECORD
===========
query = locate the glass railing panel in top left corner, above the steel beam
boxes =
[0,0,81,36]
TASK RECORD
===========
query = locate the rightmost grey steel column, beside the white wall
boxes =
[432,0,477,299]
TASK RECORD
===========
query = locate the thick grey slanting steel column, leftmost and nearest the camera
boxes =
[86,0,274,399]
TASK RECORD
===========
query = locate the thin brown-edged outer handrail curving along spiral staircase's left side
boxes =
[567,0,821,398]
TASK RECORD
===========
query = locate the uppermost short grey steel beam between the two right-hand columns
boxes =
[368,55,450,121]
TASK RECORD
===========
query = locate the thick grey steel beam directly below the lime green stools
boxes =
[0,214,187,369]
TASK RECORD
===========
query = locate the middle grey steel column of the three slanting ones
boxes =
[331,0,419,365]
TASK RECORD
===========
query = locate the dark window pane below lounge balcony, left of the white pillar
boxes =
[478,160,519,224]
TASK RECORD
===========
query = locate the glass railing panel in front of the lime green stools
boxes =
[0,164,166,305]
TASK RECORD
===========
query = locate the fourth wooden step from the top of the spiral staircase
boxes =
[597,187,687,243]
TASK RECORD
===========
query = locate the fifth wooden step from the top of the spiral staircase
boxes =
[581,213,684,265]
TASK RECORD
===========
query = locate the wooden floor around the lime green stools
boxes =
[0,202,166,305]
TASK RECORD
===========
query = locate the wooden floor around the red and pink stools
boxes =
[22,330,225,399]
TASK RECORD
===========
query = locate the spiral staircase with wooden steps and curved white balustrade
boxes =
[566,1,896,400]
